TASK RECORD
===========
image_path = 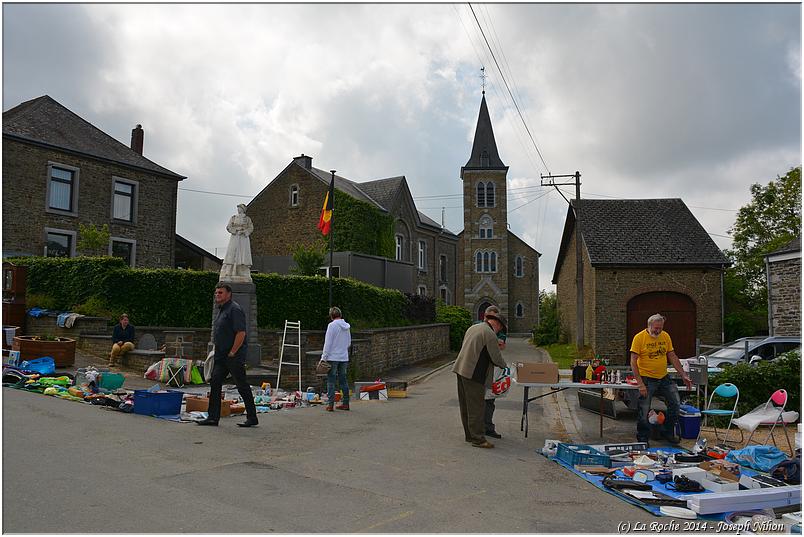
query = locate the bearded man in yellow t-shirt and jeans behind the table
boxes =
[631,313,692,444]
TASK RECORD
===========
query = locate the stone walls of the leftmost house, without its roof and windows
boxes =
[3,138,178,268]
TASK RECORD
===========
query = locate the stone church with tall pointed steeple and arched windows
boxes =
[458,93,541,333]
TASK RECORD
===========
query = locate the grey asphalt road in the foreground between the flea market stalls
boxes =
[3,340,658,533]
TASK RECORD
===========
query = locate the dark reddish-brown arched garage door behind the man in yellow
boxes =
[626,291,696,358]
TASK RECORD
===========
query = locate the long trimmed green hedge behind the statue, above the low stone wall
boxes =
[9,257,418,330]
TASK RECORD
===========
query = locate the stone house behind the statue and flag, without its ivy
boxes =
[247,155,458,304]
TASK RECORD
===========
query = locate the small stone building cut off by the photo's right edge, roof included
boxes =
[765,237,801,337]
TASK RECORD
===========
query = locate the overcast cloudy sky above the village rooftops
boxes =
[3,4,801,288]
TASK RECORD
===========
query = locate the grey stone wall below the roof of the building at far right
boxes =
[768,257,801,337]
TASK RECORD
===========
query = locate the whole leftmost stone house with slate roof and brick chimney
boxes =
[3,95,185,268]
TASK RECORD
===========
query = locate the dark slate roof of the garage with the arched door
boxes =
[553,198,729,283]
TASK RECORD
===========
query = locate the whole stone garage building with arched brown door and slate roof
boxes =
[553,199,729,362]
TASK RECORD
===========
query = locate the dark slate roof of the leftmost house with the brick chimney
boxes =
[3,95,186,180]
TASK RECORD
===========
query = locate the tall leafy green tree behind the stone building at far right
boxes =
[724,166,801,339]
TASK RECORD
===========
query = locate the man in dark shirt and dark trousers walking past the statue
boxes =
[198,283,258,427]
